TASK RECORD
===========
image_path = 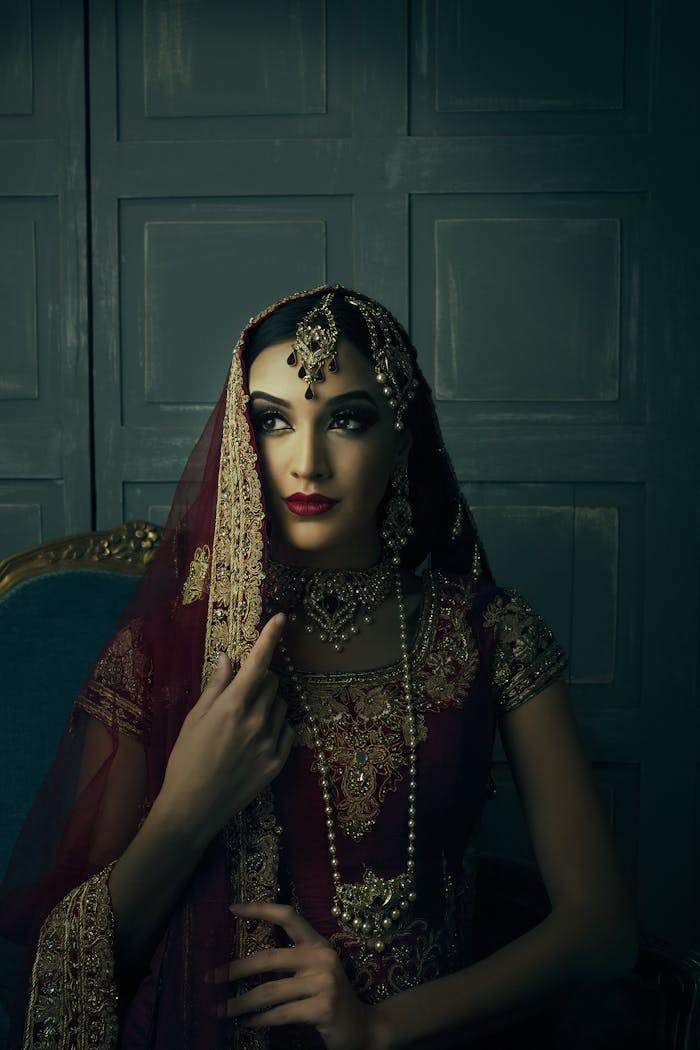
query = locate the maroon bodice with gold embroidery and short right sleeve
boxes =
[274,572,566,1002]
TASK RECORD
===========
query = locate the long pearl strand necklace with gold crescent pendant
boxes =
[279,568,418,952]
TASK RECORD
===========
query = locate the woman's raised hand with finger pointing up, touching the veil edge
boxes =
[153,613,294,845]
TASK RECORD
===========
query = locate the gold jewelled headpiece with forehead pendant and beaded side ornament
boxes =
[287,292,418,431]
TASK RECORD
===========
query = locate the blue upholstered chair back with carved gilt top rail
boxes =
[0,522,161,1047]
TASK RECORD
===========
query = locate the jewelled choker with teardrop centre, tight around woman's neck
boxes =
[267,560,394,652]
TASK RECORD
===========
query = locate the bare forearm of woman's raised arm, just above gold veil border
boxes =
[109,799,211,969]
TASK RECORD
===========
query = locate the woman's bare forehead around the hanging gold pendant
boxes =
[248,337,385,405]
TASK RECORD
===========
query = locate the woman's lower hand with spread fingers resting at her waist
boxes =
[212,902,382,1050]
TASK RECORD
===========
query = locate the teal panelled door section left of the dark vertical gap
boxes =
[0,0,91,557]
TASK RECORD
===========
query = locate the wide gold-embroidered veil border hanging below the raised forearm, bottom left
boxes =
[23,864,119,1050]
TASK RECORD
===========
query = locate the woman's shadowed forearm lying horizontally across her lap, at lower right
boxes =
[372,910,638,1050]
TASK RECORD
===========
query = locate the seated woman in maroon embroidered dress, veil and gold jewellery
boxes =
[3,286,636,1050]
